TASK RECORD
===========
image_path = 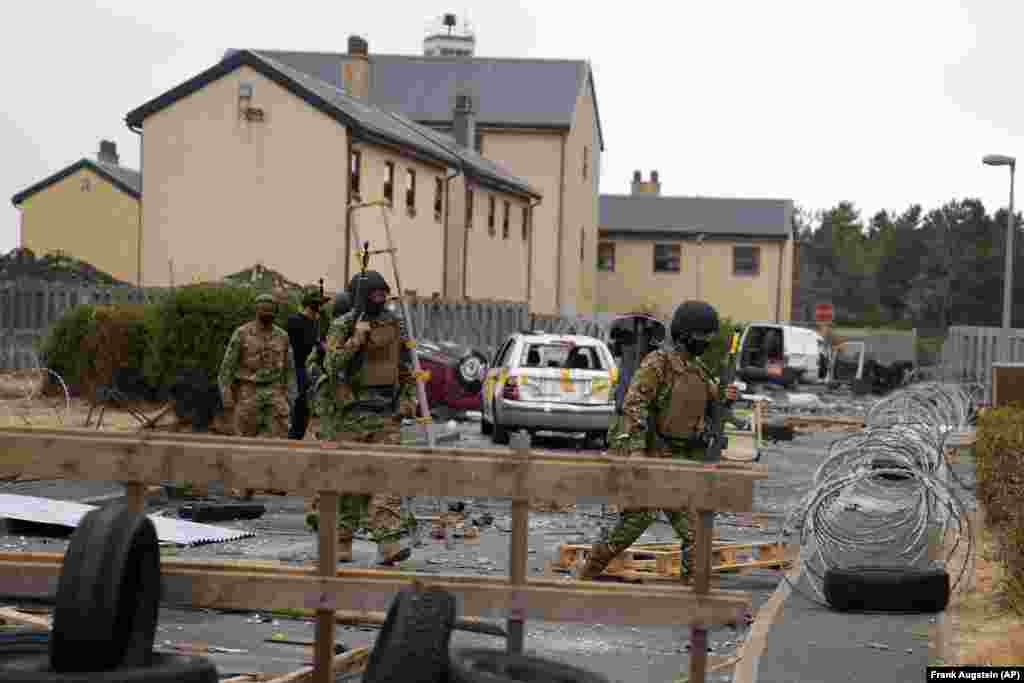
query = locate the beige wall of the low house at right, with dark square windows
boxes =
[597,238,793,321]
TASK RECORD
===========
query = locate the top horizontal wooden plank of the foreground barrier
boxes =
[0,429,768,512]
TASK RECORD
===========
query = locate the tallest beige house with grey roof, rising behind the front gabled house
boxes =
[226,19,604,314]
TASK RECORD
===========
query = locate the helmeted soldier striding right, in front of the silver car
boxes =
[580,301,737,581]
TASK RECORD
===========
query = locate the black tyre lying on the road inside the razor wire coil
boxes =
[823,567,949,613]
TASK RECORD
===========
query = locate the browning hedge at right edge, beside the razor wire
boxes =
[975,402,1024,613]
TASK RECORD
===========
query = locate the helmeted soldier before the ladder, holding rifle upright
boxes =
[307,270,416,565]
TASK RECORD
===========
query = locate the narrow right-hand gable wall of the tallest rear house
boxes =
[561,73,601,315]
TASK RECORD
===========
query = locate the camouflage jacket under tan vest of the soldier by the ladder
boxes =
[306,310,416,417]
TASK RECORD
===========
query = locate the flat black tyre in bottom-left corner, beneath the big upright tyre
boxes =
[0,650,219,683]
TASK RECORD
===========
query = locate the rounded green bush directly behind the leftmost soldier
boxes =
[145,284,298,386]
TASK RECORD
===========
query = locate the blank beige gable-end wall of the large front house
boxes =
[142,67,351,290]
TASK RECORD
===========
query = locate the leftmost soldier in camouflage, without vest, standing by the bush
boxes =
[217,294,298,498]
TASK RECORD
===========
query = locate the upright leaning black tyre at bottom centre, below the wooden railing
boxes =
[362,588,456,683]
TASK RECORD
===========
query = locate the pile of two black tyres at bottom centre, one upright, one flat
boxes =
[362,588,608,683]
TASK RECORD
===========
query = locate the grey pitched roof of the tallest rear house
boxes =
[225,49,604,150]
